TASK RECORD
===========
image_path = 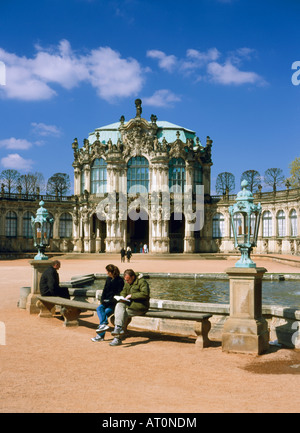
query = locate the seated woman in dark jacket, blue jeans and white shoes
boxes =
[92,265,124,342]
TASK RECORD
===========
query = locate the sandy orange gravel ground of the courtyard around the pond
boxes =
[0,254,300,414]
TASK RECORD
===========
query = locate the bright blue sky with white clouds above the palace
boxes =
[0,0,300,193]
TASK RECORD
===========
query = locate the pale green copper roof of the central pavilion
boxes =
[88,121,196,144]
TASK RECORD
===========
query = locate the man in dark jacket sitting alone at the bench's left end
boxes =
[40,260,70,299]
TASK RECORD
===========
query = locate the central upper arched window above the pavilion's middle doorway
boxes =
[127,156,149,194]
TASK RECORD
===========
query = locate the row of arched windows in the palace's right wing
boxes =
[212,209,298,238]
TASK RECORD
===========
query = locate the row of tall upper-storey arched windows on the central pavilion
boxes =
[81,156,203,194]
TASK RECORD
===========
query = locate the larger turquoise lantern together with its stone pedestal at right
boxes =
[222,180,269,355]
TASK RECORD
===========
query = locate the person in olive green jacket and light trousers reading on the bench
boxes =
[110,269,150,346]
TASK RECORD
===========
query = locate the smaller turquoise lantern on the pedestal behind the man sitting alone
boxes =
[31,201,53,260]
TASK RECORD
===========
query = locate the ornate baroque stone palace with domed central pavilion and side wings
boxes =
[0,99,300,258]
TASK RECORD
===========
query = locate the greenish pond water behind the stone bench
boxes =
[93,277,300,309]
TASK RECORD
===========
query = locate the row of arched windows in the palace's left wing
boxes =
[5,211,73,239]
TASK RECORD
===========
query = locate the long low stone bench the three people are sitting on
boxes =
[36,295,212,348]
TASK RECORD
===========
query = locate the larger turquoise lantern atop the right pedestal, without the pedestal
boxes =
[229,180,261,268]
